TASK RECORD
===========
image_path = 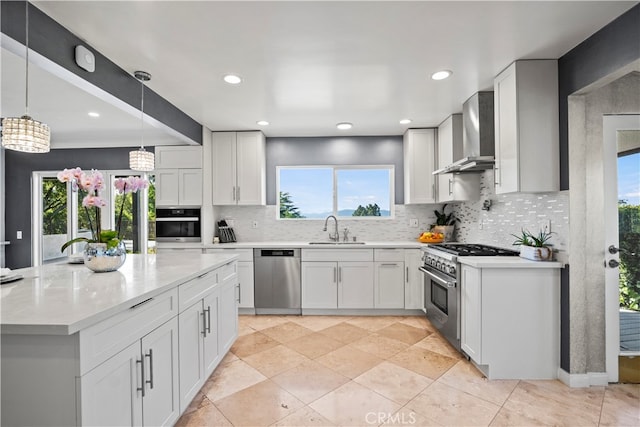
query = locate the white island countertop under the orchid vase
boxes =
[0,253,237,335]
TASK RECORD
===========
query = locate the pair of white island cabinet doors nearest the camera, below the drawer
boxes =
[80,317,180,426]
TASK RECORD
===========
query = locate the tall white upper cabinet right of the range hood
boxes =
[494,59,560,194]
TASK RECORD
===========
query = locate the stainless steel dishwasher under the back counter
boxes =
[253,249,302,314]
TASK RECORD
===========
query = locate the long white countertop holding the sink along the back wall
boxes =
[156,240,426,249]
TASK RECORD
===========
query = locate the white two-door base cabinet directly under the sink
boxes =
[302,249,374,310]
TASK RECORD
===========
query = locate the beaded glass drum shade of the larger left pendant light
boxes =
[2,115,51,153]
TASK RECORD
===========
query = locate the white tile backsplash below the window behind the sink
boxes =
[212,205,438,242]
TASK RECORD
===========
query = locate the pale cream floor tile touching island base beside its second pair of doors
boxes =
[202,360,267,402]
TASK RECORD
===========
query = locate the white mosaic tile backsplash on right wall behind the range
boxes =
[447,170,569,261]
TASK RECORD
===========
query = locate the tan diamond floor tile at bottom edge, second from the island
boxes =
[214,380,304,426]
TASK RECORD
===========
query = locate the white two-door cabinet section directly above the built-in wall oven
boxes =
[154,169,202,206]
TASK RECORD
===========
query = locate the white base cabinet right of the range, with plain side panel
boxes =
[460,265,560,379]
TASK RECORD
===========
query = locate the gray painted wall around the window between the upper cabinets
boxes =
[266,136,404,205]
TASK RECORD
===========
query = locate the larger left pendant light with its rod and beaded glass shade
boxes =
[2,1,51,153]
